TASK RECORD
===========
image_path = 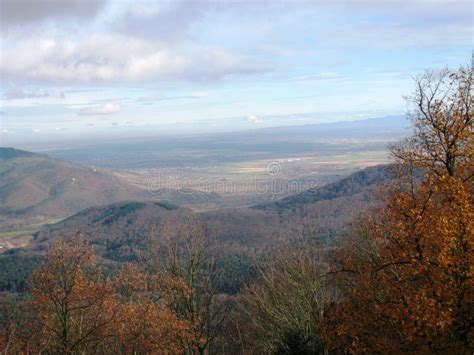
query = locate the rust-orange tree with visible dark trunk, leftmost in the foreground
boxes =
[24,238,119,353]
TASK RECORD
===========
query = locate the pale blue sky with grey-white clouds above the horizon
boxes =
[0,0,474,145]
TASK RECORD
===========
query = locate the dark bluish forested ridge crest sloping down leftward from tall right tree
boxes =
[255,164,393,211]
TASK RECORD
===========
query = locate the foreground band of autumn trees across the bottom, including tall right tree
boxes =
[0,68,474,354]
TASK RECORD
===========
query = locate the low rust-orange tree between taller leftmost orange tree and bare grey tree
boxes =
[112,264,194,354]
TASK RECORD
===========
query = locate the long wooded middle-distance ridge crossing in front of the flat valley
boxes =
[31,165,396,260]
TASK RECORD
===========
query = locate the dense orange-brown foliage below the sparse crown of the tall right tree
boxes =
[328,172,474,352]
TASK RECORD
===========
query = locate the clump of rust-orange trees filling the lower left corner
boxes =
[0,238,193,354]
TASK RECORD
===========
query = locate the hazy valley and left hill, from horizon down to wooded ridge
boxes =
[0,117,406,252]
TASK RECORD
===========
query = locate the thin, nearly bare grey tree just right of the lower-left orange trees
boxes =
[142,215,228,354]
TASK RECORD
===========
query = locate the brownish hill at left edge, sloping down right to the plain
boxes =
[0,148,148,218]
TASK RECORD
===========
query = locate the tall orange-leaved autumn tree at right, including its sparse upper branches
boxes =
[321,64,474,353]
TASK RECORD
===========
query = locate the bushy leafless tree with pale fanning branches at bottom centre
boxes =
[239,249,334,354]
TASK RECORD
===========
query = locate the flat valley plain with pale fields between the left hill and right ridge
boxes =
[112,150,388,209]
